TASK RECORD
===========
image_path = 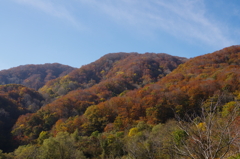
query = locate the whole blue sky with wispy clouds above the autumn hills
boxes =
[0,0,240,70]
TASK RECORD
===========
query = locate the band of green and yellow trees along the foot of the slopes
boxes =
[0,99,240,159]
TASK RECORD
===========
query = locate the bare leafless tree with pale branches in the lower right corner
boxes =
[173,97,240,159]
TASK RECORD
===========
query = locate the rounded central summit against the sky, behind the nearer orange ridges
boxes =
[40,53,186,97]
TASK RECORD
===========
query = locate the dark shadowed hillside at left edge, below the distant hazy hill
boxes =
[0,84,44,150]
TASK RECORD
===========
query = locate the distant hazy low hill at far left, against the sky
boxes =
[0,63,75,90]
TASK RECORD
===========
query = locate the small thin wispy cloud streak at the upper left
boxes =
[14,0,80,27]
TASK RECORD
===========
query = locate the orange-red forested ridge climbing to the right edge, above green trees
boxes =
[89,46,240,127]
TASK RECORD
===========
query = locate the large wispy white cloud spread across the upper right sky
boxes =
[78,0,233,46]
